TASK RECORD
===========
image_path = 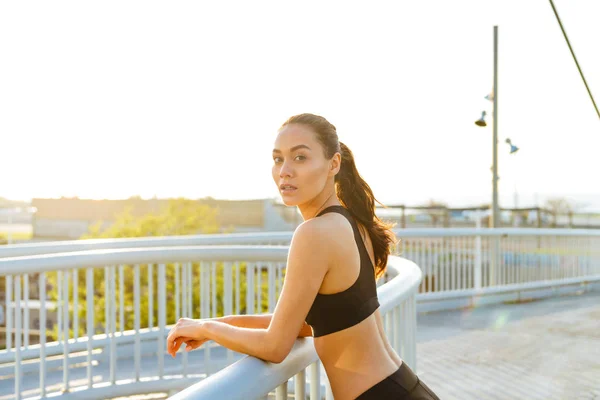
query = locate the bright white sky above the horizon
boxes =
[0,0,600,209]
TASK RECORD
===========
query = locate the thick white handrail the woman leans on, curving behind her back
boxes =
[170,256,422,400]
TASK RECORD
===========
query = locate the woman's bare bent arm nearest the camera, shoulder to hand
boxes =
[167,218,334,363]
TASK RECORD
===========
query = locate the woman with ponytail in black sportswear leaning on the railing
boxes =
[167,114,437,400]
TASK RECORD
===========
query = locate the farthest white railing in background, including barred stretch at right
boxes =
[5,228,600,293]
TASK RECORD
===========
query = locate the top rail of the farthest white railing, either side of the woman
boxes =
[0,228,600,259]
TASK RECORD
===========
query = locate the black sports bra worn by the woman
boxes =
[306,206,379,337]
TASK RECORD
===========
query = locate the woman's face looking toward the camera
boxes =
[273,124,335,206]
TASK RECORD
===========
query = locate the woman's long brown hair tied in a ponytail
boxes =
[280,114,396,278]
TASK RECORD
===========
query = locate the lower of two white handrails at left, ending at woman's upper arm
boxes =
[0,246,289,276]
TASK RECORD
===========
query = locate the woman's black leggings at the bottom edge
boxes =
[356,362,440,400]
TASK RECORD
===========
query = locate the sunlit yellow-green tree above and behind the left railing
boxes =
[48,198,237,338]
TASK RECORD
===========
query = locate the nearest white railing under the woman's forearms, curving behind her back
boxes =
[166,257,421,400]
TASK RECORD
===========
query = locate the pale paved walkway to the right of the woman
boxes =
[417,292,600,400]
